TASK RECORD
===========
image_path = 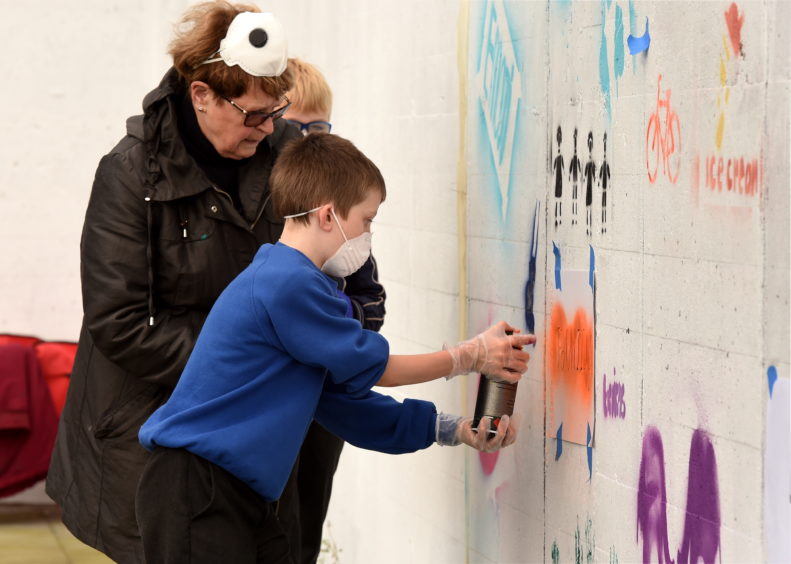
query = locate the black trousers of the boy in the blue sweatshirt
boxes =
[135,448,293,564]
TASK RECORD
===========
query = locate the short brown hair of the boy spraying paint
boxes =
[269,133,386,223]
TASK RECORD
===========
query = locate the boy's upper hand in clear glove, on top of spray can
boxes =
[442,321,536,383]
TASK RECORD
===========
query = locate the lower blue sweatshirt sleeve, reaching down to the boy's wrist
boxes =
[315,383,437,454]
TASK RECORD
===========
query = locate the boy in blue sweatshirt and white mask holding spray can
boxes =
[136,133,535,563]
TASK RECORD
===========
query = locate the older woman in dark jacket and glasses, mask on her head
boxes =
[47,2,384,562]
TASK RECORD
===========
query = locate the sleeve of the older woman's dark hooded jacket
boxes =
[80,154,205,387]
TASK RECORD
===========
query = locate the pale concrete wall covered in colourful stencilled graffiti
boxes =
[0,0,791,563]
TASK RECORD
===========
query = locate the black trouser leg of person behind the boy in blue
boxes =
[277,421,344,564]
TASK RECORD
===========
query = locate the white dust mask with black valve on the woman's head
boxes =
[200,12,288,76]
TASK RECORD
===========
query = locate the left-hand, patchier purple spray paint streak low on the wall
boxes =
[636,426,673,564]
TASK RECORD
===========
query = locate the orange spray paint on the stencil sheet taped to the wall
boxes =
[547,302,594,438]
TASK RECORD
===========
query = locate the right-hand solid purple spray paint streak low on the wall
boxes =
[676,429,720,564]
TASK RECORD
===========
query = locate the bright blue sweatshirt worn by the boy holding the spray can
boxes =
[139,243,436,501]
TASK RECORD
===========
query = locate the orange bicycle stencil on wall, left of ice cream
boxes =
[645,74,681,184]
